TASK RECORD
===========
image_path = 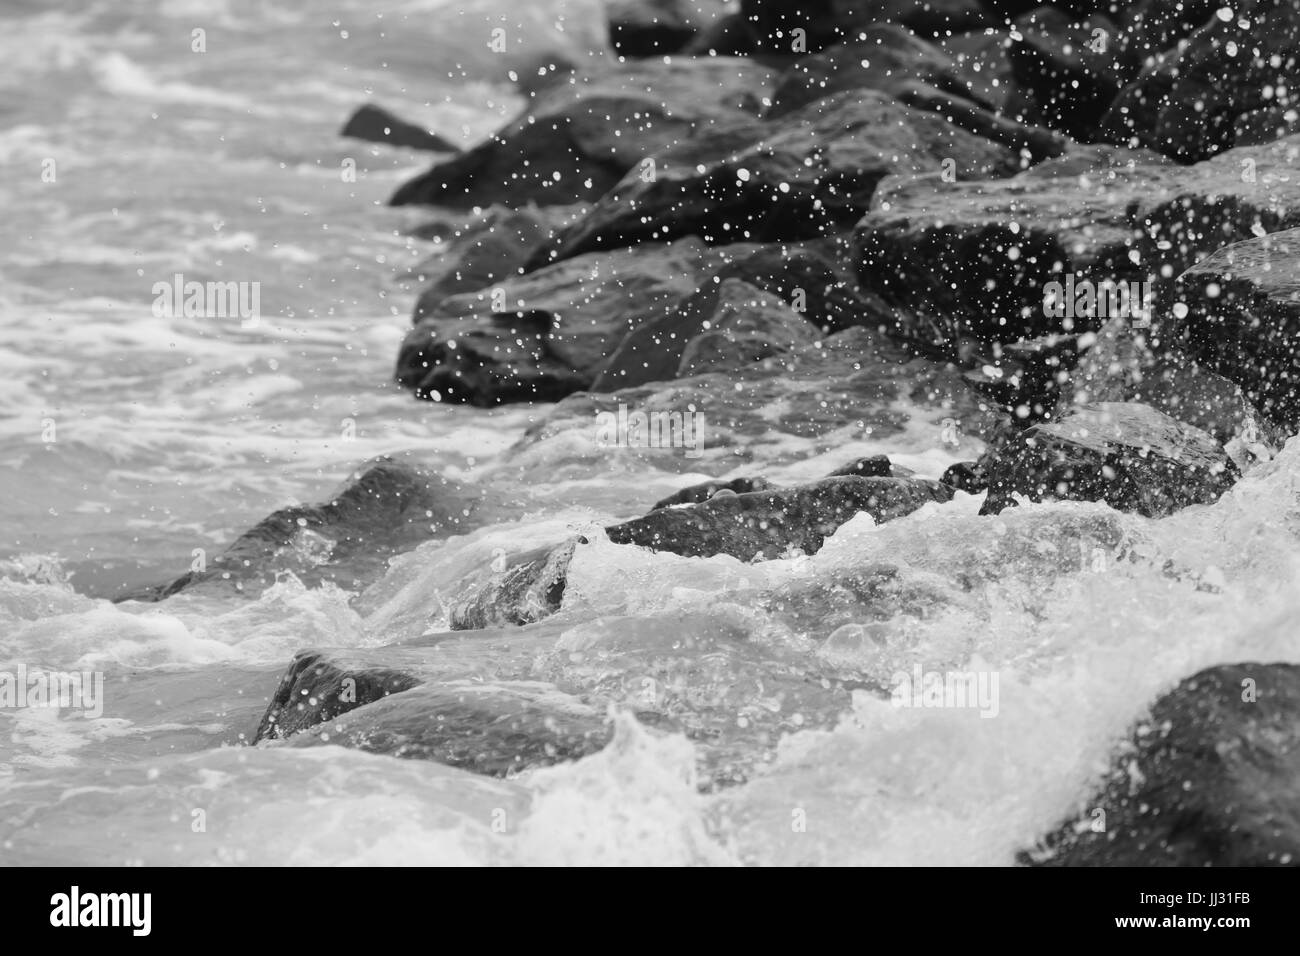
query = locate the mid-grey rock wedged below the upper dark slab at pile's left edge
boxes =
[415,206,579,321]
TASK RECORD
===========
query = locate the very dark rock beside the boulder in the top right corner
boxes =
[1008,7,1139,142]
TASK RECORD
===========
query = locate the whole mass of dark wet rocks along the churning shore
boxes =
[144,0,1300,866]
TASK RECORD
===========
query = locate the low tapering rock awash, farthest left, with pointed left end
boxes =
[118,458,480,601]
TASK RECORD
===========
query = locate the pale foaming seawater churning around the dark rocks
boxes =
[0,0,1300,865]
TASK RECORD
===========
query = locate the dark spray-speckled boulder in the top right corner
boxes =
[1102,0,1300,163]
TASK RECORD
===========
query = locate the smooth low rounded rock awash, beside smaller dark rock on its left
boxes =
[289,680,611,777]
